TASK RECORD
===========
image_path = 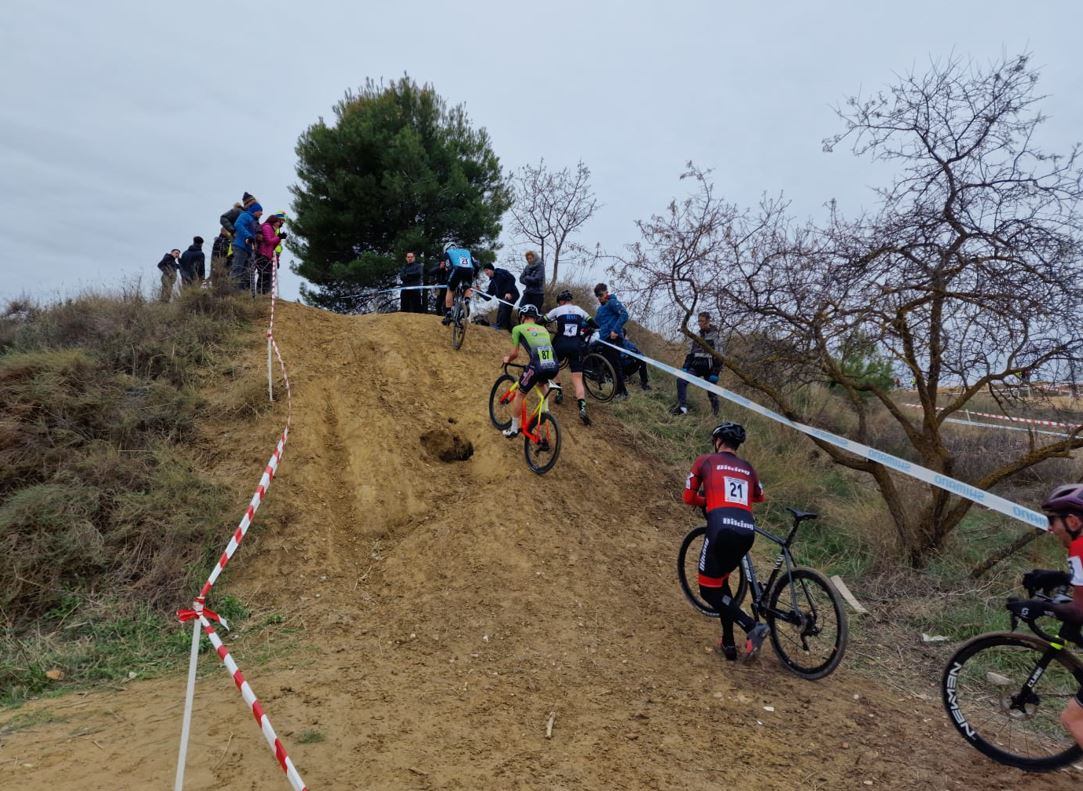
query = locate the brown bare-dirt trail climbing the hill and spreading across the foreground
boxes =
[0,304,1079,791]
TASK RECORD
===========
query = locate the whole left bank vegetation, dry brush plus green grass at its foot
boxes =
[0,289,265,703]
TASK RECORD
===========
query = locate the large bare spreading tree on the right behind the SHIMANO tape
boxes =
[618,56,1083,566]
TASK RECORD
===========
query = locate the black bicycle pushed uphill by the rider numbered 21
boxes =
[677,508,848,680]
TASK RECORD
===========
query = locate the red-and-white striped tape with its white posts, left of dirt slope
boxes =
[173,258,305,791]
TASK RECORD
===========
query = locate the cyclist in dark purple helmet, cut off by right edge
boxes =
[1008,483,1083,747]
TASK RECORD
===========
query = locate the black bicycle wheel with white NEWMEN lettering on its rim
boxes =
[940,632,1083,771]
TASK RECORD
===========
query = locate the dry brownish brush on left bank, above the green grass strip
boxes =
[0,289,255,626]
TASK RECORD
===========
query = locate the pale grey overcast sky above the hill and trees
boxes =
[0,0,1083,299]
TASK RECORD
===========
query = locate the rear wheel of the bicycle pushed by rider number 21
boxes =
[766,568,848,680]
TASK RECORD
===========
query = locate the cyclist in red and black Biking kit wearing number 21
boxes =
[684,423,769,662]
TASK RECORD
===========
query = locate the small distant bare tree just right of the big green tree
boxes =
[511,159,598,283]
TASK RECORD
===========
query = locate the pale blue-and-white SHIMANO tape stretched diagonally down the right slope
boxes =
[600,340,1049,530]
